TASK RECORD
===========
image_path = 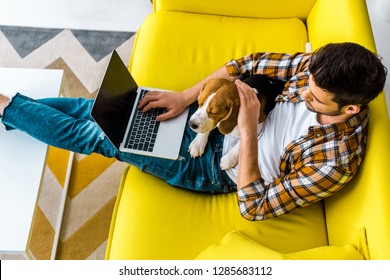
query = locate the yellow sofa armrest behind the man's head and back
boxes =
[307,0,390,259]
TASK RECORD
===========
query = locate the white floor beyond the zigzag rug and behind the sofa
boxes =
[0,0,390,115]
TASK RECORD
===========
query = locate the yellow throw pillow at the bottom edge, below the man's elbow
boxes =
[196,230,364,260]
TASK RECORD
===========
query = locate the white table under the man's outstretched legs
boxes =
[0,68,69,259]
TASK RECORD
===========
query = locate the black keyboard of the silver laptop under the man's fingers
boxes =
[125,90,164,152]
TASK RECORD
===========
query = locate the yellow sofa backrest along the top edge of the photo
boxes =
[153,0,316,19]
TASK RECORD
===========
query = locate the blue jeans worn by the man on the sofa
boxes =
[2,93,236,193]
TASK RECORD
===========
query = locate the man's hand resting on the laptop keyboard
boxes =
[138,91,189,121]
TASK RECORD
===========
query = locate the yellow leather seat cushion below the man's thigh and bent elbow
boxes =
[106,166,328,259]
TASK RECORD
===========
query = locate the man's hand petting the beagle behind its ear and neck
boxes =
[236,80,261,139]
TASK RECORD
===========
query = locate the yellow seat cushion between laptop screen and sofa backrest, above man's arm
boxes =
[129,12,307,90]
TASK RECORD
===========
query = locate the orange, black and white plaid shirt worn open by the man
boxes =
[226,53,369,220]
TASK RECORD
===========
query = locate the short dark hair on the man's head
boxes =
[309,43,387,107]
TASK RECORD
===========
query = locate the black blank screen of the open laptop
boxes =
[91,51,137,149]
